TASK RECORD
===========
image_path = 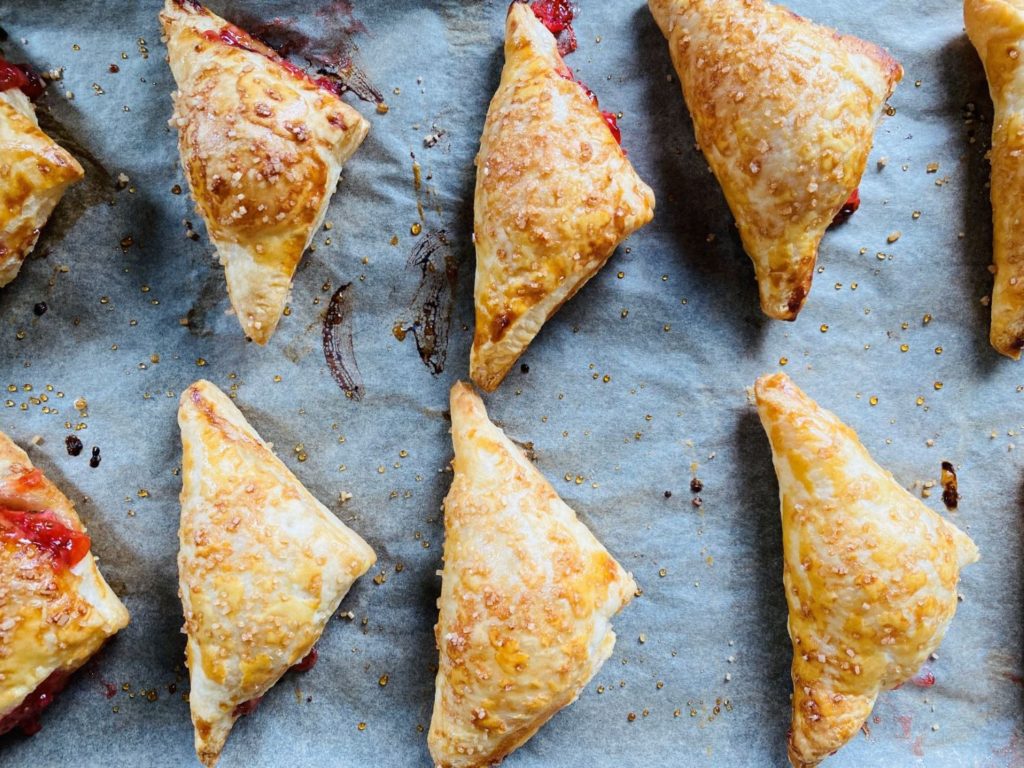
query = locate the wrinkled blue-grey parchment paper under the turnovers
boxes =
[0,0,1024,768]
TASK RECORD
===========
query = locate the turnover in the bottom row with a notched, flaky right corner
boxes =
[428,383,636,768]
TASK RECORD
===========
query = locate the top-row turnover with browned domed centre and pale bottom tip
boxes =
[160,0,370,344]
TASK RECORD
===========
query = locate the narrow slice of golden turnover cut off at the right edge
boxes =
[964,0,1024,359]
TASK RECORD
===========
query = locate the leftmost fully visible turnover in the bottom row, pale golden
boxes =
[178,381,376,766]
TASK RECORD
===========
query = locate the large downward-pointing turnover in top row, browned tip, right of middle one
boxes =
[648,0,903,321]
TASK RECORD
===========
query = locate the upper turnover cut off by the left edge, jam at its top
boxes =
[0,57,85,288]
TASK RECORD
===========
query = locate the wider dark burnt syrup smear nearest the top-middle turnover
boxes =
[393,229,459,375]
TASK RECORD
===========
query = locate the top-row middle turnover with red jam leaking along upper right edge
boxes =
[470,2,654,391]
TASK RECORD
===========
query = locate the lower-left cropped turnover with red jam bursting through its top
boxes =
[0,432,128,734]
